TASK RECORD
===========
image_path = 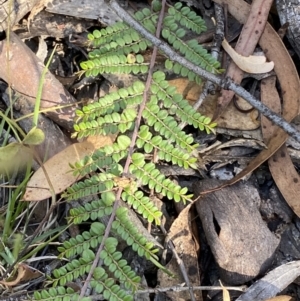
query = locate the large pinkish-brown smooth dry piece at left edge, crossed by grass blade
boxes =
[0,31,77,131]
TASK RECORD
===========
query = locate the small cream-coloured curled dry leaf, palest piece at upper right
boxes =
[222,39,274,74]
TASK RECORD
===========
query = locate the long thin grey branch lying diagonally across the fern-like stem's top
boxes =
[109,0,300,142]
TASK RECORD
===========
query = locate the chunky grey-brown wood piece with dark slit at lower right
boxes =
[193,179,279,285]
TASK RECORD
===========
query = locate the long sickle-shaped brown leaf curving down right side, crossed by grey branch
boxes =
[202,0,300,194]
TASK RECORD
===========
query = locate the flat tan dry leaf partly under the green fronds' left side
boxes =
[23,136,115,201]
